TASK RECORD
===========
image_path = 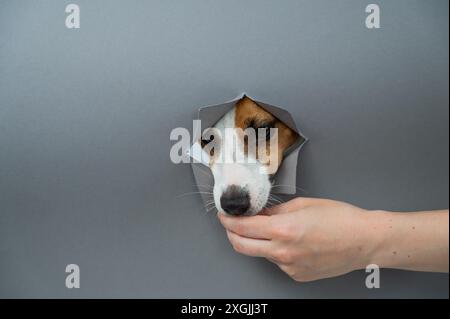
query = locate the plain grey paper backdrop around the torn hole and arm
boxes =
[0,0,449,298]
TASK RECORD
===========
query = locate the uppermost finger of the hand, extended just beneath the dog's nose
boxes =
[218,213,271,239]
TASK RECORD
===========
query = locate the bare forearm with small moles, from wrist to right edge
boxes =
[365,210,449,272]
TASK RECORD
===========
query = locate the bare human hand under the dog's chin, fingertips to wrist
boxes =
[219,198,372,281]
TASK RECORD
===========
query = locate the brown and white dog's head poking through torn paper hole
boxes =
[200,96,300,216]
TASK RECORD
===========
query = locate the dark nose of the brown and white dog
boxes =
[220,185,250,216]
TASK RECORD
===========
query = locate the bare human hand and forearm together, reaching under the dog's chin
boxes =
[218,198,448,281]
